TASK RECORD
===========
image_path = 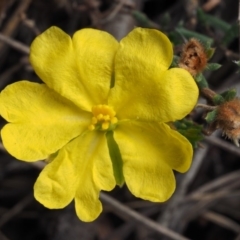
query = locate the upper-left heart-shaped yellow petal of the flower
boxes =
[30,27,118,111]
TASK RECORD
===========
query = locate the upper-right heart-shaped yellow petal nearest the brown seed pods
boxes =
[109,28,198,122]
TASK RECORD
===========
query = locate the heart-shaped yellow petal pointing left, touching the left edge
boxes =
[0,81,91,161]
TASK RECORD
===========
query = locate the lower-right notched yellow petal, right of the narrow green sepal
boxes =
[114,121,193,202]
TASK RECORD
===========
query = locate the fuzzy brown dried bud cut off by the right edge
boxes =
[216,98,240,147]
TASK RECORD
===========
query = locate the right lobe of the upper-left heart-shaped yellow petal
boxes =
[73,29,119,109]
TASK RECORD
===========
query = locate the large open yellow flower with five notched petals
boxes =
[0,27,198,221]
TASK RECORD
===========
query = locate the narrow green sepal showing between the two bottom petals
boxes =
[106,131,125,187]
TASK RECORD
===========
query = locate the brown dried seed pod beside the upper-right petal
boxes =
[178,38,208,76]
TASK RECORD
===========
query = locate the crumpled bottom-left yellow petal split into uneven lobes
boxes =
[34,132,115,222]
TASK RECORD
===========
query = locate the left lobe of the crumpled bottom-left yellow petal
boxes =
[34,148,78,209]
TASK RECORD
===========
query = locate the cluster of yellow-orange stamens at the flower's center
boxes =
[88,104,118,130]
